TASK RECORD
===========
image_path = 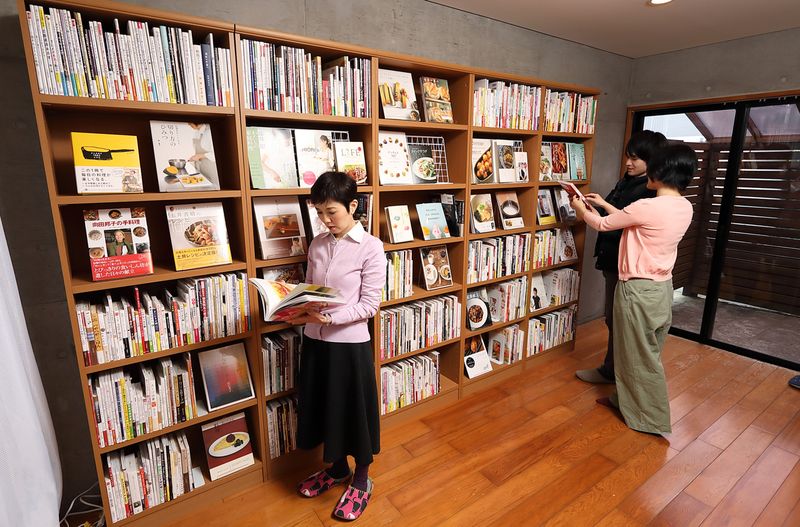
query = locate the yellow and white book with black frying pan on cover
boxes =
[70,132,144,194]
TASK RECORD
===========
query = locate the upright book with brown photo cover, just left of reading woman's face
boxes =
[253,196,307,260]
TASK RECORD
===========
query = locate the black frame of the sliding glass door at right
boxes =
[626,93,800,371]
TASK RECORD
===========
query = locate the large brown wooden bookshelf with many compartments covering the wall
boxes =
[18,0,599,526]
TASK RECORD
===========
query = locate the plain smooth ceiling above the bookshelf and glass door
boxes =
[433,0,800,58]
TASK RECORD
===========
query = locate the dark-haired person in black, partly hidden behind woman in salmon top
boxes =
[575,130,668,384]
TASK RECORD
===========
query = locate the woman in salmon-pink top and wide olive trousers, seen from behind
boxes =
[571,144,697,434]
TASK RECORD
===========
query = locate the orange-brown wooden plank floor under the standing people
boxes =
[169,321,800,527]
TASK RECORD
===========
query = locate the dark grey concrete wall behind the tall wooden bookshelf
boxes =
[0,0,632,508]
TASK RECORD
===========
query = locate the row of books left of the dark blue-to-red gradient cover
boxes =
[89,354,198,448]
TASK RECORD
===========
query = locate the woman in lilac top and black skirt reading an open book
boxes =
[291,172,386,520]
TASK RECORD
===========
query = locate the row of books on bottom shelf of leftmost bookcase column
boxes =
[104,432,198,522]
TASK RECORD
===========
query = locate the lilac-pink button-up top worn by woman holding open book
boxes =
[305,222,386,342]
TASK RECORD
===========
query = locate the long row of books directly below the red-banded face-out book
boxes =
[75,273,252,366]
